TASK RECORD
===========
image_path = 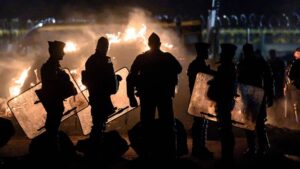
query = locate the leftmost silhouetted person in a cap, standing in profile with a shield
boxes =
[39,41,77,140]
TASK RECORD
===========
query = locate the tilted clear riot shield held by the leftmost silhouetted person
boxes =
[7,69,88,139]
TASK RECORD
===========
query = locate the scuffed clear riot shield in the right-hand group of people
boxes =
[188,73,264,130]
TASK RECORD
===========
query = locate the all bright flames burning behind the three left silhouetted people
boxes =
[4,23,174,118]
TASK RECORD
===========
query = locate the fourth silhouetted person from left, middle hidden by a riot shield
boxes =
[187,43,215,159]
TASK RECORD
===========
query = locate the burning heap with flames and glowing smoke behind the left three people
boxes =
[0,10,186,120]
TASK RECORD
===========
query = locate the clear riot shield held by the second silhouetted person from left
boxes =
[78,68,139,135]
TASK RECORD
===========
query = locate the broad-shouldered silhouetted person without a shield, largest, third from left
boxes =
[127,33,182,158]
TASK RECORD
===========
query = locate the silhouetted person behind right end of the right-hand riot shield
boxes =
[238,44,274,156]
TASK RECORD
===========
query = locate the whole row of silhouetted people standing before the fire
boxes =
[2,30,300,167]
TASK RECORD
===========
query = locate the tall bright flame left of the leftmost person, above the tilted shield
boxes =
[9,67,31,97]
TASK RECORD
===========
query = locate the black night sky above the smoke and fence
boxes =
[0,0,300,19]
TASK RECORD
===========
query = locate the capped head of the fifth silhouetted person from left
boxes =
[220,43,237,62]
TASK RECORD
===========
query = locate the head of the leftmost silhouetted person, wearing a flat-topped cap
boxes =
[48,41,66,60]
